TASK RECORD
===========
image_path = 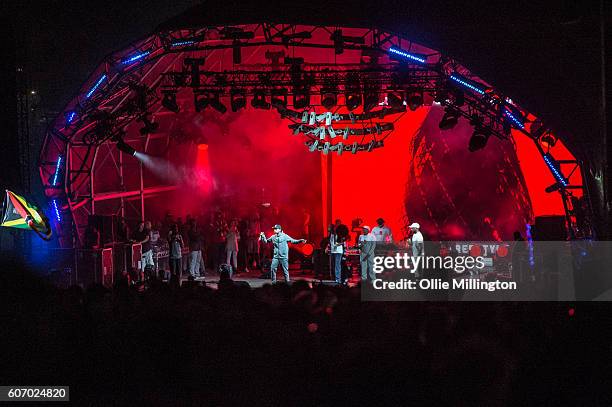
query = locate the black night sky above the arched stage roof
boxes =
[8,0,602,180]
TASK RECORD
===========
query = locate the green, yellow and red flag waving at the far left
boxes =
[0,190,52,240]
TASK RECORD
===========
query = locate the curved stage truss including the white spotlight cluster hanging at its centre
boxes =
[39,23,583,246]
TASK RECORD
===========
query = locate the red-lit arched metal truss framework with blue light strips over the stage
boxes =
[39,23,586,246]
